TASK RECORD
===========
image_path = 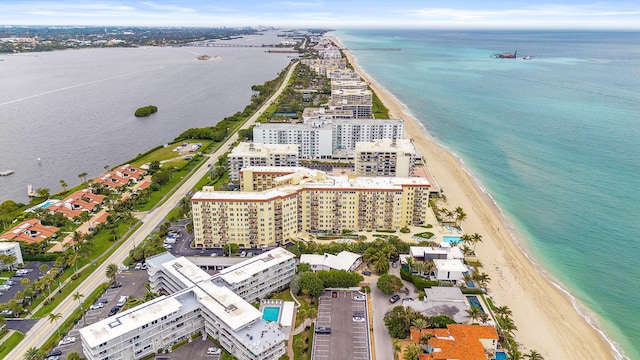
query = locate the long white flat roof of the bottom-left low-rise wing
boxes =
[79,296,182,348]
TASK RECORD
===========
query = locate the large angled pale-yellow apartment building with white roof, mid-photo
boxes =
[191,171,430,248]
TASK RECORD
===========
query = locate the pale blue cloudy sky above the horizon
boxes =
[0,0,640,30]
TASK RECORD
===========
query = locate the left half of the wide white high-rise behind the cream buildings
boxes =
[253,123,331,159]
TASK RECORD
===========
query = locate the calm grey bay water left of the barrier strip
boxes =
[0,32,291,202]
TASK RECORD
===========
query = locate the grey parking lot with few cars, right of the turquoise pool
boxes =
[311,290,371,360]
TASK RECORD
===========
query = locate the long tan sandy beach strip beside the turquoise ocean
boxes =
[332,38,616,360]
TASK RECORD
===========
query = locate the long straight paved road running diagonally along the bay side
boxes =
[6,60,297,359]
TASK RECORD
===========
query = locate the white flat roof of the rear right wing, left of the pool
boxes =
[220,247,295,284]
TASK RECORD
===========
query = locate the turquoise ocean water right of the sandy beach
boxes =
[332,30,640,359]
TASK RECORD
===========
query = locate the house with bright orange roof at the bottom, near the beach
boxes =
[411,324,498,360]
